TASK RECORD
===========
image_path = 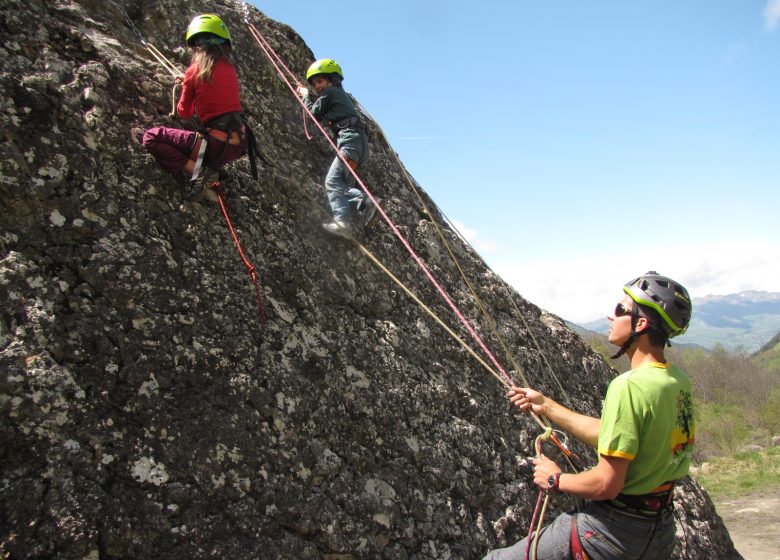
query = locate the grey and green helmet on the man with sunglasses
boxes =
[623,271,693,338]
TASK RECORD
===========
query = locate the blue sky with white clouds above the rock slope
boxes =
[251,0,780,322]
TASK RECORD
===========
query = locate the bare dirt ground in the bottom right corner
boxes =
[715,488,780,560]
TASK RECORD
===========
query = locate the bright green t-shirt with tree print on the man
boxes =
[598,363,696,494]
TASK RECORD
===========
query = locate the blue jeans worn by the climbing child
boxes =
[325,134,370,222]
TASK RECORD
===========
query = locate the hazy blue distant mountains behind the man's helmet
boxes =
[580,291,780,352]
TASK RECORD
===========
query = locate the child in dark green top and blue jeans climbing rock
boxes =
[298,58,384,238]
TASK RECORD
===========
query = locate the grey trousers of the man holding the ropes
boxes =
[483,502,675,560]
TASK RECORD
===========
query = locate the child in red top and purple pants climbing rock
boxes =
[143,14,251,196]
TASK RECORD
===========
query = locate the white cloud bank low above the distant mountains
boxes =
[493,244,780,322]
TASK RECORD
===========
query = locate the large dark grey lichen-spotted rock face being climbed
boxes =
[0,0,737,559]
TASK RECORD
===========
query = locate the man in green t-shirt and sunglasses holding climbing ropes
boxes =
[485,272,696,560]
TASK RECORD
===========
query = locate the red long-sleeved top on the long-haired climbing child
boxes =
[176,59,243,123]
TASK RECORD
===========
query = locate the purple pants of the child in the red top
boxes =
[143,126,247,175]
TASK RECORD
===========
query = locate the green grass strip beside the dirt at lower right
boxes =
[693,447,780,498]
